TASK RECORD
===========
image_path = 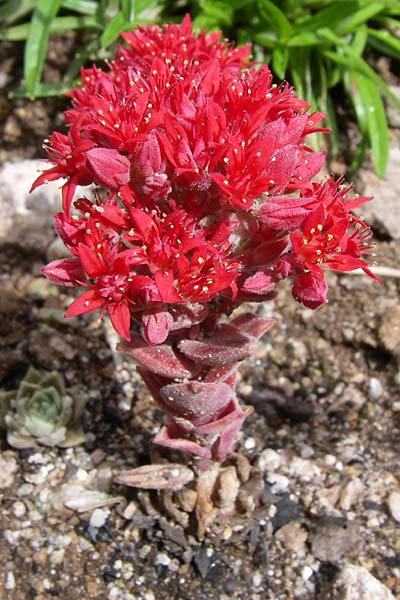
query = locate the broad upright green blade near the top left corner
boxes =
[24,0,61,96]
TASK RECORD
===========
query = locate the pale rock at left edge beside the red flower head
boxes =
[0,160,61,254]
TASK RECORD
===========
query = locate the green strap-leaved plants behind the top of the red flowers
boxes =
[0,0,400,177]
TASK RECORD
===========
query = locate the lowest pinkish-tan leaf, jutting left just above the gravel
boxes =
[114,463,194,490]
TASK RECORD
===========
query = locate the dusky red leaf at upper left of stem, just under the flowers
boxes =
[118,334,198,379]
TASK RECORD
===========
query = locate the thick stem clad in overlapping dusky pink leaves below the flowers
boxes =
[120,313,273,465]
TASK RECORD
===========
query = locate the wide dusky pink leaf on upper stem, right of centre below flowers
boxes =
[178,323,253,367]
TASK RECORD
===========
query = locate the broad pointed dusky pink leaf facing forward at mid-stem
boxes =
[160,381,232,427]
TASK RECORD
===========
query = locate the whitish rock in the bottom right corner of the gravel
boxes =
[332,564,396,600]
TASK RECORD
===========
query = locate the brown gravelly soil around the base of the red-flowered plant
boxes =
[0,231,400,600]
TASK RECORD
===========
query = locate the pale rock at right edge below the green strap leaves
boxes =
[356,137,400,240]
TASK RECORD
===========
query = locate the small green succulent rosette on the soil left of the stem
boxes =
[0,367,88,449]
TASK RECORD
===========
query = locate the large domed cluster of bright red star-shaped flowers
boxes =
[33,17,378,460]
